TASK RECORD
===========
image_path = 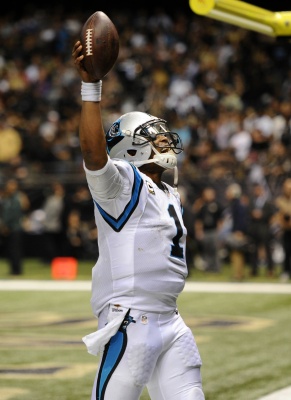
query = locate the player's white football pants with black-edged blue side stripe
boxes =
[91,310,205,400]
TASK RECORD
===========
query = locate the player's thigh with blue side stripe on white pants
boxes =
[91,312,162,400]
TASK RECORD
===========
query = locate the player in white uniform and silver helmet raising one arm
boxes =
[73,41,204,400]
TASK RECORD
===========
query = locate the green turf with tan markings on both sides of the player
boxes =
[0,258,291,400]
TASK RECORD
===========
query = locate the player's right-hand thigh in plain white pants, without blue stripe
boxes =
[147,329,204,400]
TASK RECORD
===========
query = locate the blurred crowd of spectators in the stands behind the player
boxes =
[0,5,291,280]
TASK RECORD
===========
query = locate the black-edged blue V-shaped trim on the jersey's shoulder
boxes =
[94,164,143,232]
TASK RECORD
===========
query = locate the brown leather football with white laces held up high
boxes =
[80,11,119,81]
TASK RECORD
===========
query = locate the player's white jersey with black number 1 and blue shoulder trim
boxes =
[84,159,188,317]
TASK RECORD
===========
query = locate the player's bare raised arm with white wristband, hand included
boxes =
[72,41,108,171]
